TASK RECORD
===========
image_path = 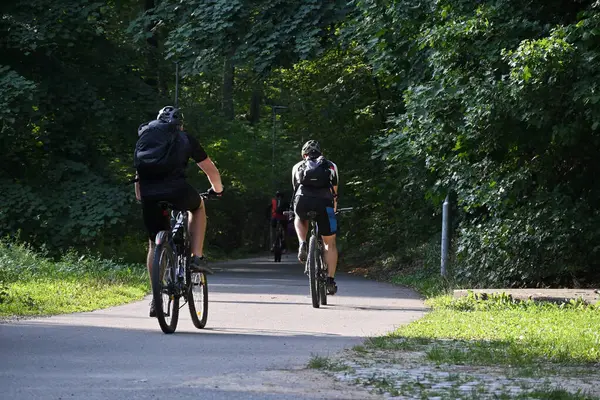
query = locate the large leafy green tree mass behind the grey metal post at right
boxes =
[358,1,600,286]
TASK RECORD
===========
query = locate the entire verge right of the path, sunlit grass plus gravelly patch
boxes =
[321,258,600,400]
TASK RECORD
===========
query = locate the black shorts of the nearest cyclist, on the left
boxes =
[142,184,201,240]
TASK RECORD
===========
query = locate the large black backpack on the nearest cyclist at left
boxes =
[133,121,181,179]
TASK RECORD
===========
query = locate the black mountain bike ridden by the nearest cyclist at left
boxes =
[151,192,217,333]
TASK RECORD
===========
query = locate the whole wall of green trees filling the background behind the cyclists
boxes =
[0,0,600,286]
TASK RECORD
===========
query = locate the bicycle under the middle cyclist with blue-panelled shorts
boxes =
[306,207,352,308]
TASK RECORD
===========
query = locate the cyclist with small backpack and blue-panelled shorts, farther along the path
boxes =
[292,140,338,294]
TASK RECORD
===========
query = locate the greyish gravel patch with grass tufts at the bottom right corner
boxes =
[318,350,600,399]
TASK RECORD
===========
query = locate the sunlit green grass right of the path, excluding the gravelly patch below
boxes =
[367,296,600,366]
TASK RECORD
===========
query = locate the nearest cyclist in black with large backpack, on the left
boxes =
[134,106,223,317]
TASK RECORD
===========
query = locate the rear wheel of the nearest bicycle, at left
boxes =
[152,231,179,333]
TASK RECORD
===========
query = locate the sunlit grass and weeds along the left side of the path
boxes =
[0,242,149,317]
